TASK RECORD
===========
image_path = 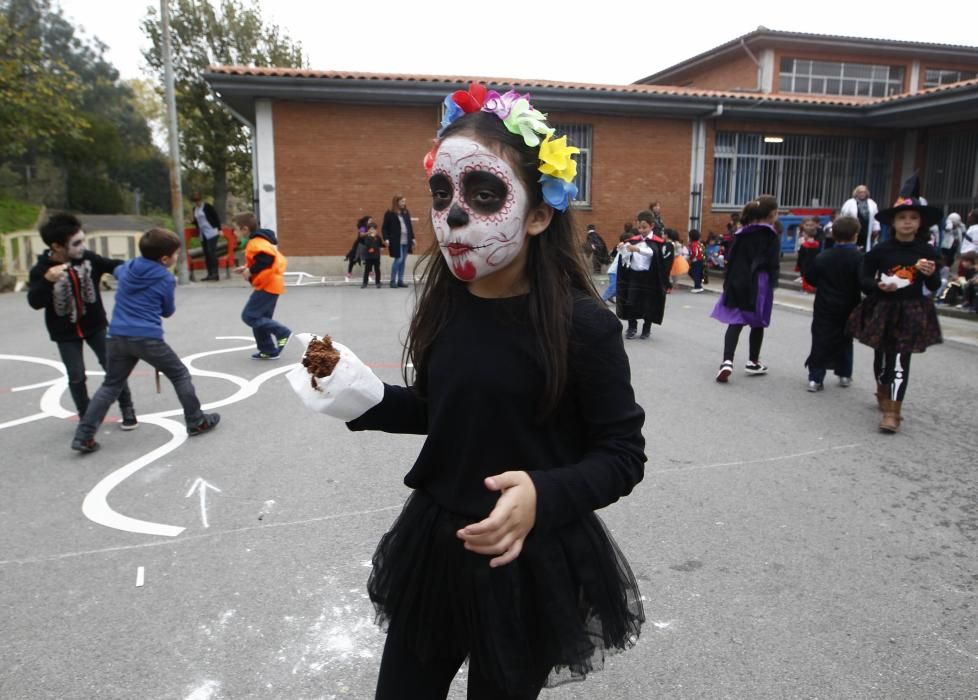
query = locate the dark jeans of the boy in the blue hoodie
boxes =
[75,335,204,440]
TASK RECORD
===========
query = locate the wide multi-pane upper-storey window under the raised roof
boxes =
[779,58,904,97]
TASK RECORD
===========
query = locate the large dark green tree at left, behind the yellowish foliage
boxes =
[0,0,169,213]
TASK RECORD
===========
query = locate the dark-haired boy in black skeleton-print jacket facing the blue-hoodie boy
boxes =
[27,214,138,422]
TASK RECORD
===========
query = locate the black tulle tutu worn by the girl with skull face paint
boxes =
[367,490,645,693]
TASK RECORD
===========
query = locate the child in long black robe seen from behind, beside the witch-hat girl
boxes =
[802,216,863,391]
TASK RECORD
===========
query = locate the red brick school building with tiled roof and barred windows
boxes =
[206,27,978,271]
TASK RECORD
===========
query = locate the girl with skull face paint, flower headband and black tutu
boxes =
[290,85,645,699]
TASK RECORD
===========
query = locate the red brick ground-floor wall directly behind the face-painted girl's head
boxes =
[274,102,692,256]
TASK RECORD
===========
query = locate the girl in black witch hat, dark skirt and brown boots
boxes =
[849,173,942,433]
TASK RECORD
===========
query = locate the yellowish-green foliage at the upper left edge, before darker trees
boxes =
[0,1,87,159]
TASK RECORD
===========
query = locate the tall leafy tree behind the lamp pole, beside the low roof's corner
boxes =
[143,0,305,215]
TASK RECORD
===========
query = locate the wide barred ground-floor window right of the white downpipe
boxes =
[713,131,893,209]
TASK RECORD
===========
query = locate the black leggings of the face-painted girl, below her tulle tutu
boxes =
[376,634,550,700]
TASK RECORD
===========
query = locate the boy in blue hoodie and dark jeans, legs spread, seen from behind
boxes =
[71,228,221,452]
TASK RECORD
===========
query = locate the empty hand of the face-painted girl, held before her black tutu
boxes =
[455,472,537,568]
